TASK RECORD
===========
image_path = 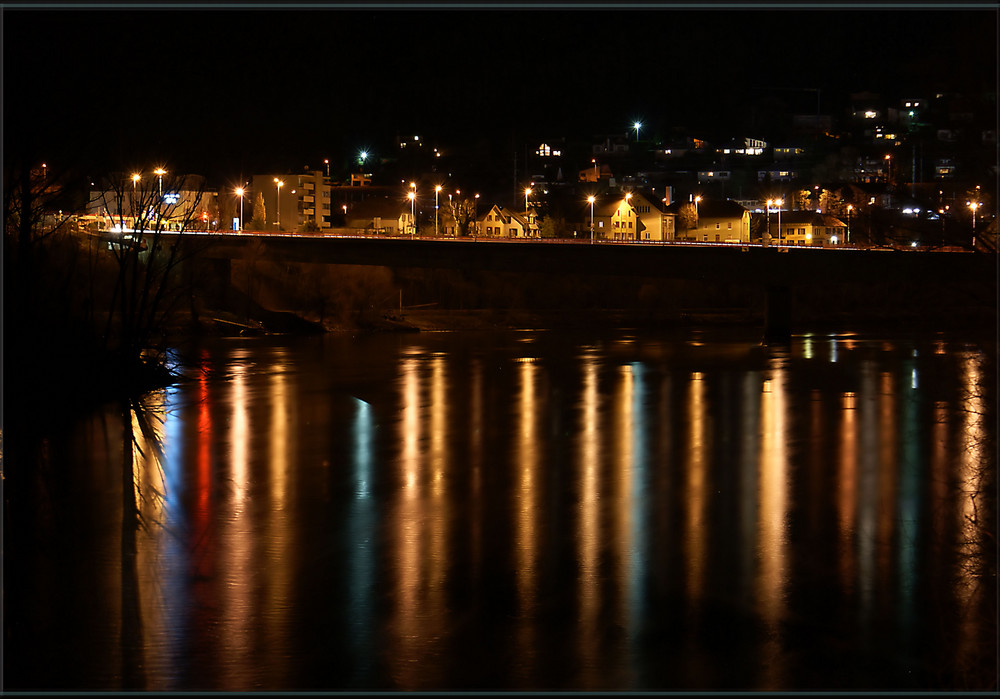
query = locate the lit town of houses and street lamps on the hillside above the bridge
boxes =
[58,93,997,251]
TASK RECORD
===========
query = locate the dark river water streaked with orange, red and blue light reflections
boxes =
[5,333,996,691]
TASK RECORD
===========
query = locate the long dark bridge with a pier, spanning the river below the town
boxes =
[165,232,997,338]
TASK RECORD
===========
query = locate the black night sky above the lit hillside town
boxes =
[3,5,997,183]
